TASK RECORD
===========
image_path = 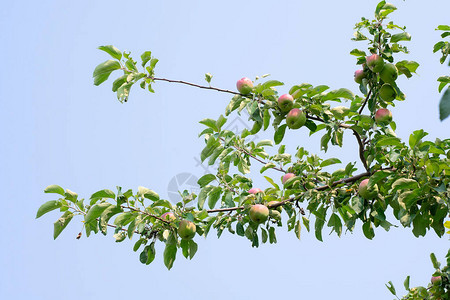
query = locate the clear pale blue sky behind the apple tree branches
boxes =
[0,0,450,300]
